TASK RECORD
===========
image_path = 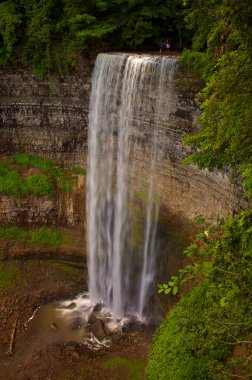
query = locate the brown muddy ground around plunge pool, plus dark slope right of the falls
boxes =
[0,215,196,380]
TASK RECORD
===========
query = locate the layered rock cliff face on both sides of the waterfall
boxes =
[0,56,245,229]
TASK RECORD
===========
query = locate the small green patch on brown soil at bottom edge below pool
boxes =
[102,357,145,380]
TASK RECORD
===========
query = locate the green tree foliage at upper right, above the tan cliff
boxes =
[181,0,252,196]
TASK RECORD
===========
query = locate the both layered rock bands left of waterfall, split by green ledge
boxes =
[0,66,92,230]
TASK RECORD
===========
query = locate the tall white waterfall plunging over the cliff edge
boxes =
[87,54,177,318]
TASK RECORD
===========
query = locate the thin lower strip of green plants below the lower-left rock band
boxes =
[0,227,62,247]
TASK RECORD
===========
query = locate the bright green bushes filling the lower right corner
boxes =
[147,211,252,380]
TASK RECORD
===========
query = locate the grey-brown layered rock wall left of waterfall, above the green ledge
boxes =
[0,66,91,166]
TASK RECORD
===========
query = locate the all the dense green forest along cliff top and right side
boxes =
[0,0,252,380]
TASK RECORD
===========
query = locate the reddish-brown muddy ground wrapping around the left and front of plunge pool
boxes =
[0,257,152,380]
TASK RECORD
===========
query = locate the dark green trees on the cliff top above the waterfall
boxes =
[0,0,190,75]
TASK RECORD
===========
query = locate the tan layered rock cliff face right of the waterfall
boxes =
[126,63,245,220]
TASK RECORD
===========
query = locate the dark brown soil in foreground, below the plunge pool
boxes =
[4,332,150,380]
